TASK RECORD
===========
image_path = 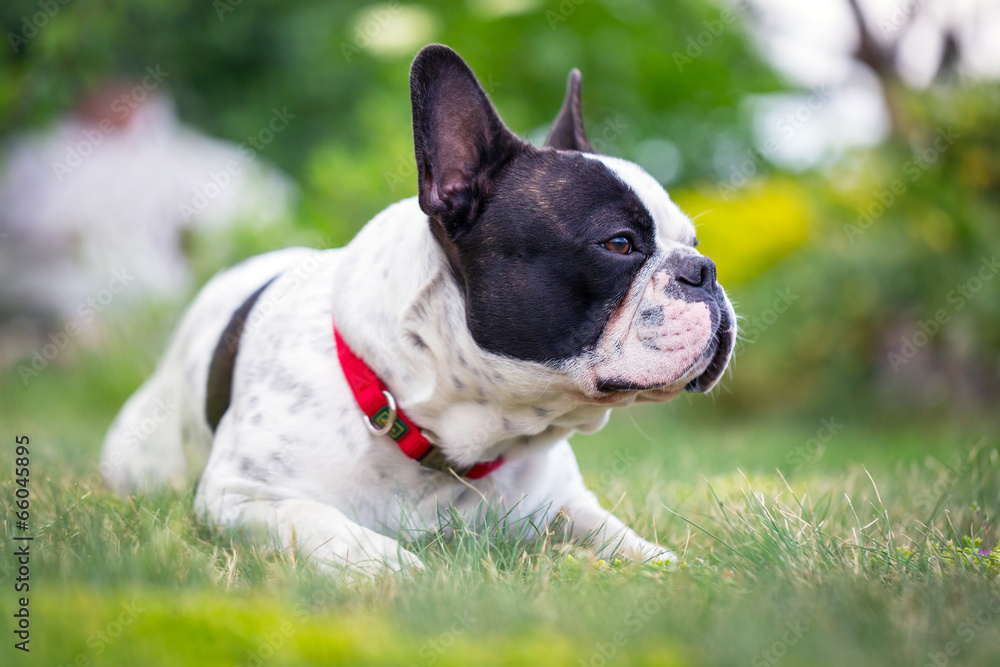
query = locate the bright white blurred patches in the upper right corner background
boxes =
[727,0,1000,170]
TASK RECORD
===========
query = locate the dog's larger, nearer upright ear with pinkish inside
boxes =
[410,44,526,232]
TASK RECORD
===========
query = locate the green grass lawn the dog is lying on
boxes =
[0,316,1000,666]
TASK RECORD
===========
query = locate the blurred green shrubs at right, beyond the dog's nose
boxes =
[724,84,1000,420]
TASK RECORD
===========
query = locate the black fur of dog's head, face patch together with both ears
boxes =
[406,45,655,366]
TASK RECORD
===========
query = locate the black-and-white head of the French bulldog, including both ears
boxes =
[410,45,736,403]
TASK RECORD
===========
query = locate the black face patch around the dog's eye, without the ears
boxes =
[453,149,656,362]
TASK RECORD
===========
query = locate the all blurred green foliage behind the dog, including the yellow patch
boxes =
[0,0,1000,416]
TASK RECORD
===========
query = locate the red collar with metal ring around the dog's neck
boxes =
[333,324,504,479]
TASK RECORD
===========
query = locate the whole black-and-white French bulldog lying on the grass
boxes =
[101,45,736,575]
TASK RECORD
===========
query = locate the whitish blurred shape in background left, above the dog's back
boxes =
[0,86,295,327]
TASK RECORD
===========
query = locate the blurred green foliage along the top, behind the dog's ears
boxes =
[0,0,780,230]
